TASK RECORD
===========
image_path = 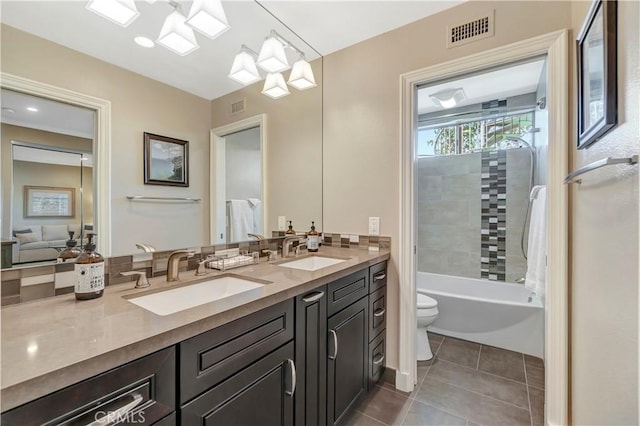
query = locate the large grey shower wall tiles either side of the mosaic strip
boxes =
[416,149,529,282]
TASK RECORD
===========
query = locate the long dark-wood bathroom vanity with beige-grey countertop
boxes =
[1,248,389,425]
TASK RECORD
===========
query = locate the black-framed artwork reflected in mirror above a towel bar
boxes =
[144,132,189,186]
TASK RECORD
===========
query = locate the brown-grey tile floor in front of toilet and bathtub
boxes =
[347,333,544,426]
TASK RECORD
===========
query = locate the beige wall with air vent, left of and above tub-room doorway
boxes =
[323,1,571,368]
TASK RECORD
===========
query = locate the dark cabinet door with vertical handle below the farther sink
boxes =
[327,297,369,425]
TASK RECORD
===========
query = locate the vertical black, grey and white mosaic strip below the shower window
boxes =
[480,150,507,281]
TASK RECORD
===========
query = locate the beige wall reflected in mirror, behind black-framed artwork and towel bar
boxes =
[1,25,211,255]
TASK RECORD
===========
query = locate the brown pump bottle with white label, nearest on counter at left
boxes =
[75,234,104,300]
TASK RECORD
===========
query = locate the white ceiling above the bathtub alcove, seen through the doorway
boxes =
[418,58,545,114]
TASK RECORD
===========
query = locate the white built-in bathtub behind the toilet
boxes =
[416,272,544,358]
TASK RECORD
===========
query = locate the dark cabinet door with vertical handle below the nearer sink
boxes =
[180,342,296,426]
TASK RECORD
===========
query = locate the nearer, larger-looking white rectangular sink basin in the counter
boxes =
[128,276,264,316]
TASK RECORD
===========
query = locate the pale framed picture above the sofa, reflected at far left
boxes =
[24,185,76,218]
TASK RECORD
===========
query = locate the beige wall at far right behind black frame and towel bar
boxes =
[571,1,640,425]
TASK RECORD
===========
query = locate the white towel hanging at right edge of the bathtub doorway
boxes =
[524,185,547,298]
